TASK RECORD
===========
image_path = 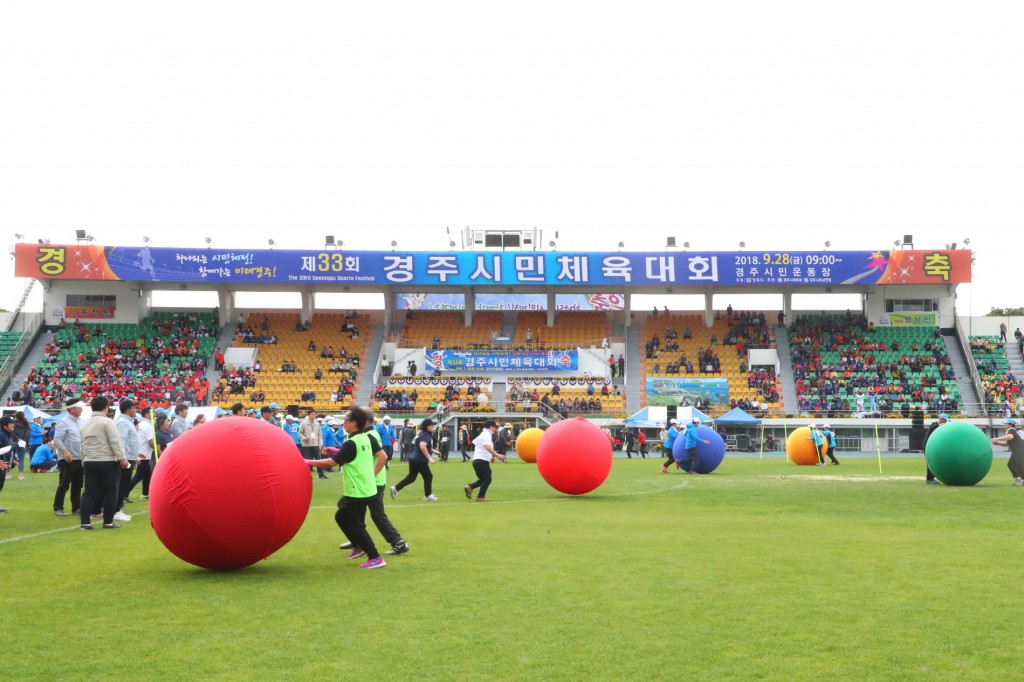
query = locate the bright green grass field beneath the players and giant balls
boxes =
[0,456,1024,680]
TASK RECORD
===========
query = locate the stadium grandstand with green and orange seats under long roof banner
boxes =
[0,231,1024,450]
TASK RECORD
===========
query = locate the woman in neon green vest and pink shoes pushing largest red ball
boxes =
[305,406,387,568]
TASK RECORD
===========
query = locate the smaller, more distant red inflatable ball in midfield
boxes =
[537,417,611,495]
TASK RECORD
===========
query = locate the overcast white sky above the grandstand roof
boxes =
[0,0,1024,314]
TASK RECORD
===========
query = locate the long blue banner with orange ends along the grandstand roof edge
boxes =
[14,244,972,284]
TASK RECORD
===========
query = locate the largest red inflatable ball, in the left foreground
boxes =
[150,417,312,570]
